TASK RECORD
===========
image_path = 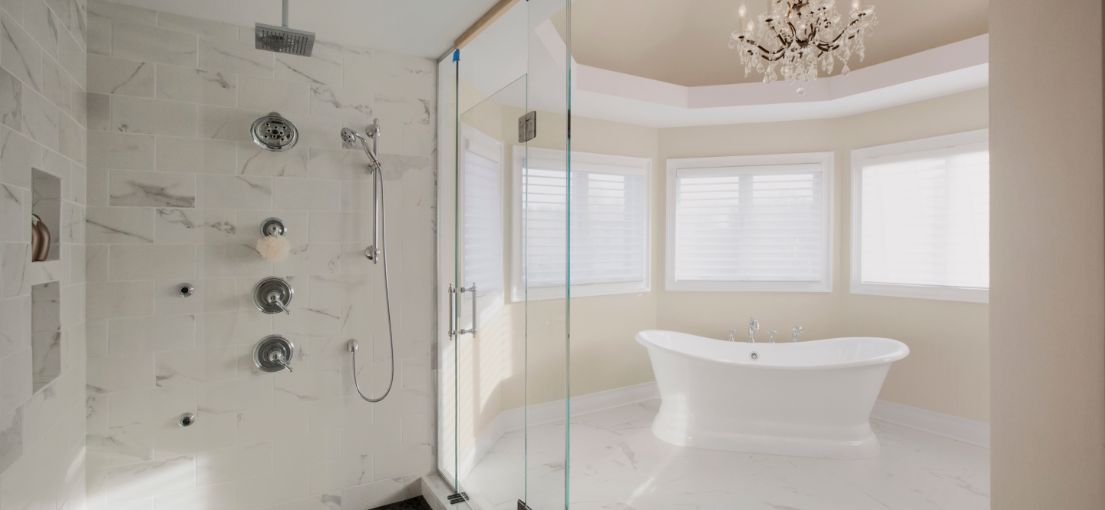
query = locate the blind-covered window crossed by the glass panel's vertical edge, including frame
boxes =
[514,146,651,300]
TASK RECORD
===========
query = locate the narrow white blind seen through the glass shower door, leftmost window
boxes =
[461,126,503,312]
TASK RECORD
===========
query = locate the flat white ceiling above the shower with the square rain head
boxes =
[106,0,496,59]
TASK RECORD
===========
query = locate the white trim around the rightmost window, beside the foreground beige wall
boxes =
[849,129,990,302]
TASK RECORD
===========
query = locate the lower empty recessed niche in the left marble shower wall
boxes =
[31,281,62,392]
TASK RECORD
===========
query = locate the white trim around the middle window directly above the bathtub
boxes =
[664,152,836,293]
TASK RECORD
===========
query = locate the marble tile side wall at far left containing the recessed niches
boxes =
[0,0,87,510]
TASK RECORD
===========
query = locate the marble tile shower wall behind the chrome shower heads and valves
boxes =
[83,1,435,510]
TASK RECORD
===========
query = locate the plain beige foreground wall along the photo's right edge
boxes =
[990,0,1105,510]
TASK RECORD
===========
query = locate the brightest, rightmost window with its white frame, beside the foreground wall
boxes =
[852,130,990,302]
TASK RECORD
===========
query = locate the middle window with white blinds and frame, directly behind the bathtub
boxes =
[666,152,832,291]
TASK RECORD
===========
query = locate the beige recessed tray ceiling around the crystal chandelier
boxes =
[554,0,989,86]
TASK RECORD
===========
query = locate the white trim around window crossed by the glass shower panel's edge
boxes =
[511,146,652,302]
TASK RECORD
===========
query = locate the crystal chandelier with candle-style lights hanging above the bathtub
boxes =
[729,0,877,83]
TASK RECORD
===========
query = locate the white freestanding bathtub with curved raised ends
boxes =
[636,330,909,458]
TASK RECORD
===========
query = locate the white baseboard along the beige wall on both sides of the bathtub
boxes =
[461,382,990,474]
